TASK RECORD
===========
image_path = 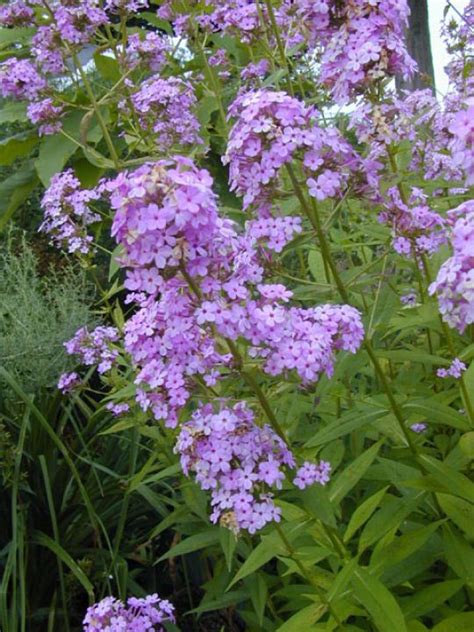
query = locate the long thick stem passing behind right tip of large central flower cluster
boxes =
[287,165,418,456]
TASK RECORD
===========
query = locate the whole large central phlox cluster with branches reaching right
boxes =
[98,157,363,426]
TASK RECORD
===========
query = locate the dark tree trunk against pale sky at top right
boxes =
[396,0,440,92]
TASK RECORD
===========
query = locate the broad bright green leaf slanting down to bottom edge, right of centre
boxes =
[351,566,407,632]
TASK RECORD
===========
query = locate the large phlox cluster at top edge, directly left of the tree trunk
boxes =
[321,0,416,103]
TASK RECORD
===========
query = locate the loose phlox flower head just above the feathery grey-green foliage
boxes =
[39,169,100,255]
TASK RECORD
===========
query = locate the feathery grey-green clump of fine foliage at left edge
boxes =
[0,230,96,393]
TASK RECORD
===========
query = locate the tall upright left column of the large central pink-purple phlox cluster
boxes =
[104,158,230,426]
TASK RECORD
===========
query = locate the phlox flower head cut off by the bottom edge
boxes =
[82,593,175,632]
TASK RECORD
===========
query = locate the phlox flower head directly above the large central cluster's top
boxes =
[120,75,201,152]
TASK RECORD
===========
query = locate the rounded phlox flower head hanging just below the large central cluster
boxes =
[175,402,295,533]
